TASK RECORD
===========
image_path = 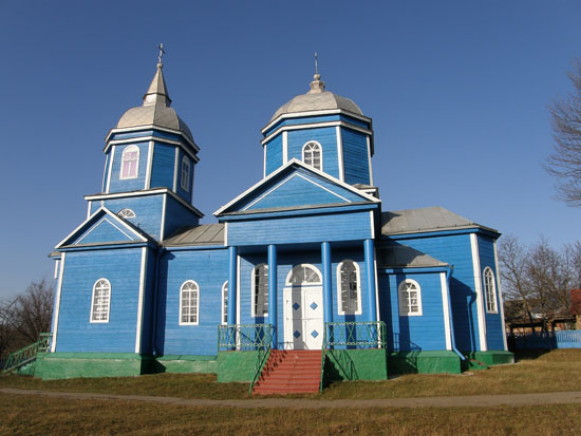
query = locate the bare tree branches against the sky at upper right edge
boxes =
[545,59,581,207]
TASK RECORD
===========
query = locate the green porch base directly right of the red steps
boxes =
[325,349,387,381]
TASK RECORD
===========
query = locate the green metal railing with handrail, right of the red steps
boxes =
[320,321,387,392]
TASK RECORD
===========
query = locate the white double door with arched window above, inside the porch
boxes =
[283,264,324,350]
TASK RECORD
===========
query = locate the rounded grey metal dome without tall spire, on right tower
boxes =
[270,74,363,121]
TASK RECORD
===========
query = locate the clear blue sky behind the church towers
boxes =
[0,0,581,298]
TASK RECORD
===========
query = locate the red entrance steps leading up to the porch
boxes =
[252,350,322,395]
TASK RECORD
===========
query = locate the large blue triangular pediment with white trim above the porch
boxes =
[215,160,379,216]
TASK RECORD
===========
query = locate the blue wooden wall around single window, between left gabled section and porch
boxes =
[156,249,228,355]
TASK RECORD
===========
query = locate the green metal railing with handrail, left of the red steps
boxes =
[218,324,273,394]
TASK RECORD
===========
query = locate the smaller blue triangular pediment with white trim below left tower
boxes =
[56,207,148,248]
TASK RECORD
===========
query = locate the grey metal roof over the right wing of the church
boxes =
[381,206,498,236]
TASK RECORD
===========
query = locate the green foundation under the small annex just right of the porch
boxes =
[388,351,462,375]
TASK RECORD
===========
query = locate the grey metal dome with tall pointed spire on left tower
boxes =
[116,62,194,142]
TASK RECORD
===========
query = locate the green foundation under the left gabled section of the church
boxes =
[34,353,147,380]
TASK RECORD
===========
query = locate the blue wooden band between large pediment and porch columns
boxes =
[228,211,372,245]
